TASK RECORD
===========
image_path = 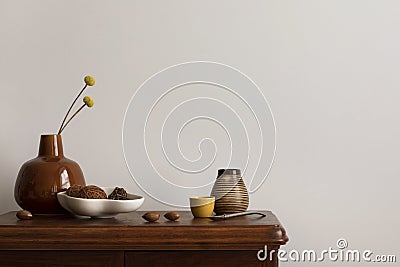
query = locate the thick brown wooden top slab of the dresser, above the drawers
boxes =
[0,211,288,250]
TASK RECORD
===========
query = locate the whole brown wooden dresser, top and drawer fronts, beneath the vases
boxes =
[0,211,288,266]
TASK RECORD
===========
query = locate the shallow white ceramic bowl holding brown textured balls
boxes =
[57,187,144,218]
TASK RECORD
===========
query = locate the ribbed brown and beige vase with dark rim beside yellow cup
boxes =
[211,169,249,215]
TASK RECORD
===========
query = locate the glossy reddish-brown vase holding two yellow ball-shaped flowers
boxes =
[14,134,86,214]
